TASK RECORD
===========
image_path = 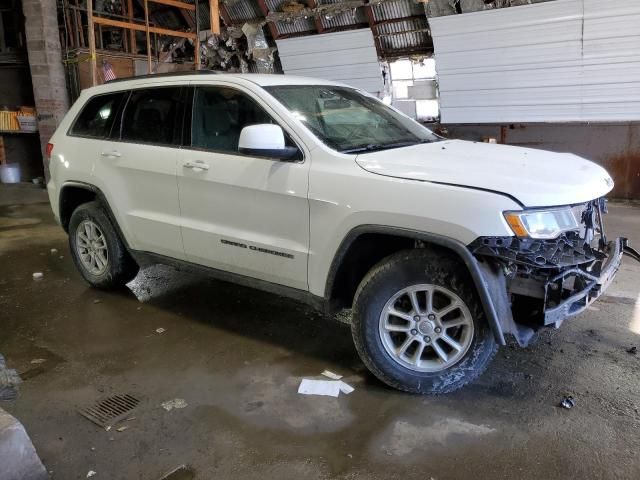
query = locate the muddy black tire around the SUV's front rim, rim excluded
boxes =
[351,249,497,394]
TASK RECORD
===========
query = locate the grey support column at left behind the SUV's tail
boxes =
[22,0,69,181]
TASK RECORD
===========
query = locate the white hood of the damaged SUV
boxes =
[356,140,613,207]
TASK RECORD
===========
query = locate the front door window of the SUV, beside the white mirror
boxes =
[191,87,275,153]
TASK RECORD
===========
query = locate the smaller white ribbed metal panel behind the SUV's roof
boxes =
[276,28,383,94]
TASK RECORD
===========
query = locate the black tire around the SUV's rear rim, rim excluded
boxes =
[69,202,139,290]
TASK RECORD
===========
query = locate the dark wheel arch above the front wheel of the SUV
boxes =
[324,225,510,345]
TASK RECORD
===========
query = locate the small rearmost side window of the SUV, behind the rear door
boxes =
[70,92,126,138]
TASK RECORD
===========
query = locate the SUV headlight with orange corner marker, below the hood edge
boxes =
[504,207,580,240]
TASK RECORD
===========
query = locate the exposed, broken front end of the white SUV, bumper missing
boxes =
[469,198,640,345]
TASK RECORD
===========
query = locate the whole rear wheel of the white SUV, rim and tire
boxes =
[69,202,139,289]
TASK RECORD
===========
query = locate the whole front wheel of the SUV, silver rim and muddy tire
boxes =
[351,250,497,394]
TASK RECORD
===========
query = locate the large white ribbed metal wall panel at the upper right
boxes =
[429,0,640,123]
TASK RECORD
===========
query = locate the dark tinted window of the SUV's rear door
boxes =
[122,87,181,145]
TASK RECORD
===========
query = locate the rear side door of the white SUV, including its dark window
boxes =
[95,85,185,259]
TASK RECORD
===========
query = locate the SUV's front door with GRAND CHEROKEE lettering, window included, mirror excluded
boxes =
[178,86,310,290]
